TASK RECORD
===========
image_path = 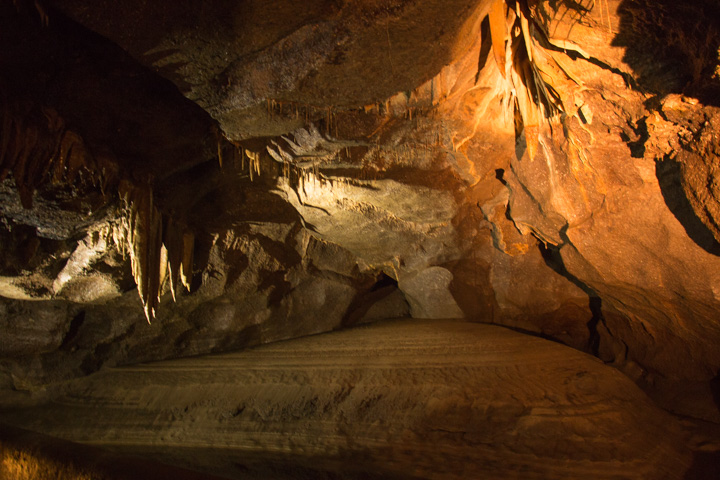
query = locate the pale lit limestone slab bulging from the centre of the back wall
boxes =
[280,176,457,270]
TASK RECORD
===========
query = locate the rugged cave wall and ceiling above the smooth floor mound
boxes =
[0,0,720,468]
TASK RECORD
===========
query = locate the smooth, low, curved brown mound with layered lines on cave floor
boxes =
[0,320,689,479]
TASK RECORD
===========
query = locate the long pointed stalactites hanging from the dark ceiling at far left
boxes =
[0,101,197,321]
